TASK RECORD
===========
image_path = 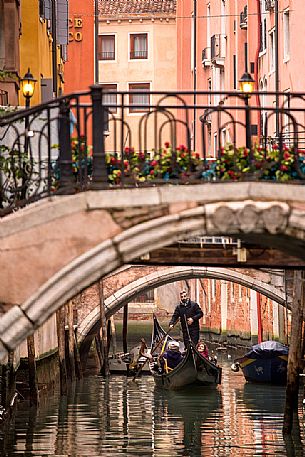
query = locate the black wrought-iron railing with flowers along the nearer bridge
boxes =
[0,86,305,215]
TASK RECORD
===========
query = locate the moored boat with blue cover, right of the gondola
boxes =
[231,341,288,384]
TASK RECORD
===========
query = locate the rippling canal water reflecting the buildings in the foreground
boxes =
[0,354,305,457]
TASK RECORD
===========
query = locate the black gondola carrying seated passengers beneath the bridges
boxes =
[150,316,221,390]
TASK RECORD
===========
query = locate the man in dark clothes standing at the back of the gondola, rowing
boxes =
[169,290,203,347]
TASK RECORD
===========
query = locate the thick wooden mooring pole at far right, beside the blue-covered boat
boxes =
[283,270,305,435]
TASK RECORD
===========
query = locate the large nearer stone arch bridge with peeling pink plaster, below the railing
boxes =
[0,182,305,358]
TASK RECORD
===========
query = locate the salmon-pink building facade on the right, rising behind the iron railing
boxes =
[177,0,305,158]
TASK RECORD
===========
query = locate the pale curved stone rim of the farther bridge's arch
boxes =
[78,266,289,342]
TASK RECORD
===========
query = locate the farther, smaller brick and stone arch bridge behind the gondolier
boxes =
[76,265,290,342]
